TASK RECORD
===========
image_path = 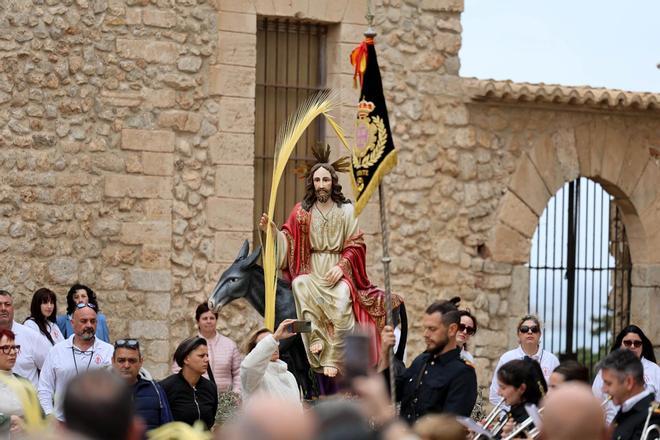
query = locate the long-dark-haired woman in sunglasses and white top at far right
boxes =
[591,325,660,423]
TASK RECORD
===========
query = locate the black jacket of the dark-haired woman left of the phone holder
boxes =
[160,371,218,429]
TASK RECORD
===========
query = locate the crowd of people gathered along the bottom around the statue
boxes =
[0,284,660,440]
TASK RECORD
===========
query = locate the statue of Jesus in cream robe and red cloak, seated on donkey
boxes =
[259,147,402,377]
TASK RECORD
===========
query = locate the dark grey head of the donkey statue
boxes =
[209,240,261,312]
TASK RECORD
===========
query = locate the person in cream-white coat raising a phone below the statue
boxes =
[241,319,302,409]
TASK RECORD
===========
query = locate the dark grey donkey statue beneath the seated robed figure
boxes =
[209,240,408,398]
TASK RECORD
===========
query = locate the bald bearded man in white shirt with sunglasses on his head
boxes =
[38,303,114,422]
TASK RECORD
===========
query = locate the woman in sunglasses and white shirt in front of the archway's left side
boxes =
[488,315,559,405]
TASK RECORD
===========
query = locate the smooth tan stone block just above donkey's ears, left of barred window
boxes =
[206,197,256,233]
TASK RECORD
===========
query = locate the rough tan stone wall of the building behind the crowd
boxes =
[0,0,660,396]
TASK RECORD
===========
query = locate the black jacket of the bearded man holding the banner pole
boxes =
[396,348,477,424]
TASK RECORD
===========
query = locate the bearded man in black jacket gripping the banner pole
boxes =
[380,301,477,424]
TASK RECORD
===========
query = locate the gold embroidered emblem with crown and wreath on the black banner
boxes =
[353,99,387,191]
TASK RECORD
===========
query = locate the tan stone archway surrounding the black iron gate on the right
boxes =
[486,110,660,350]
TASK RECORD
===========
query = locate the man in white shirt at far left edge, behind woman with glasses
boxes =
[0,290,50,388]
